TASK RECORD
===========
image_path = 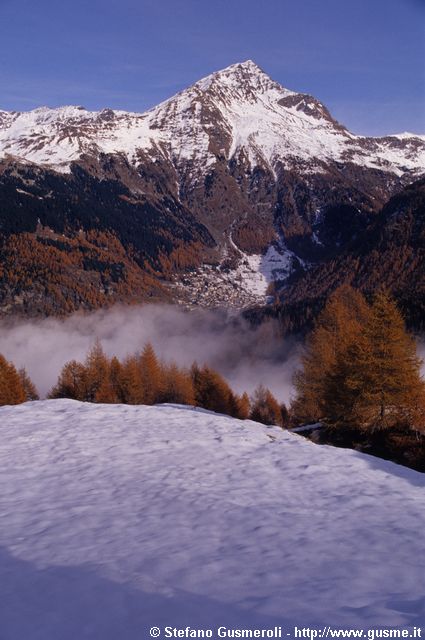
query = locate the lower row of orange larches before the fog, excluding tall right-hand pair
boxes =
[0,341,288,426]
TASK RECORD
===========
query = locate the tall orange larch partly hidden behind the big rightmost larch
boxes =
[291,285,370,423]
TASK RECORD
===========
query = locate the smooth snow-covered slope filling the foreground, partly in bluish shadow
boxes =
[0,400,425,640]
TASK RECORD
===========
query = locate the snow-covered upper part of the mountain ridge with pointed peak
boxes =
[0,60,425,175]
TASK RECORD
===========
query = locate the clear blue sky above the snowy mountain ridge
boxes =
[0,0,425,135]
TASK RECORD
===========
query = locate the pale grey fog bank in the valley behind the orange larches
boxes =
[0,305,299,402]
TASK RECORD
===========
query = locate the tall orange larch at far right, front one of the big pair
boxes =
[324,293,425,431]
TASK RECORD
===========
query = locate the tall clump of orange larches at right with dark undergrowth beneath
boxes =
[290,285,425,471]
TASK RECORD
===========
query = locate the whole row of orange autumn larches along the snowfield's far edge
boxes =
[0,285,425,461]
